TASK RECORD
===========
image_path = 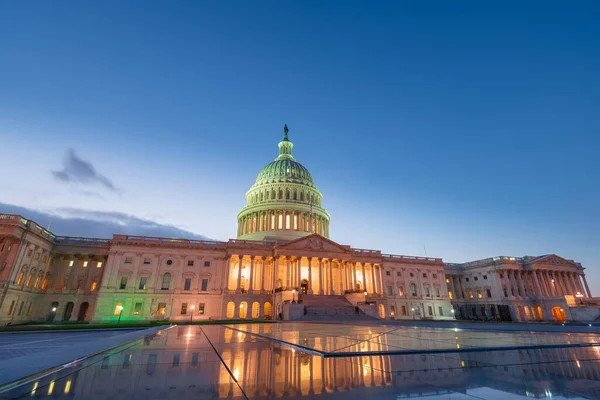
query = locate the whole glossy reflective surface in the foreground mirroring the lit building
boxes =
[1,323,600,399]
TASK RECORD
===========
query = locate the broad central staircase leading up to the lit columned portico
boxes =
[300,295,374,321]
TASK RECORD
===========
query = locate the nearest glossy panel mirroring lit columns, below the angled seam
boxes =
[13,325,600,399]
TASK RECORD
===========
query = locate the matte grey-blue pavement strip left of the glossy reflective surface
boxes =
[0,325,168,386]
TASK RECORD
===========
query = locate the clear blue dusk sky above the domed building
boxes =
[0,1,600,294]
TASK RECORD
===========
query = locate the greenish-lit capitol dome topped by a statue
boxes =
[237,125,329,240]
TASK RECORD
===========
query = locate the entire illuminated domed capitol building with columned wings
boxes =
[0,127,599,324]
